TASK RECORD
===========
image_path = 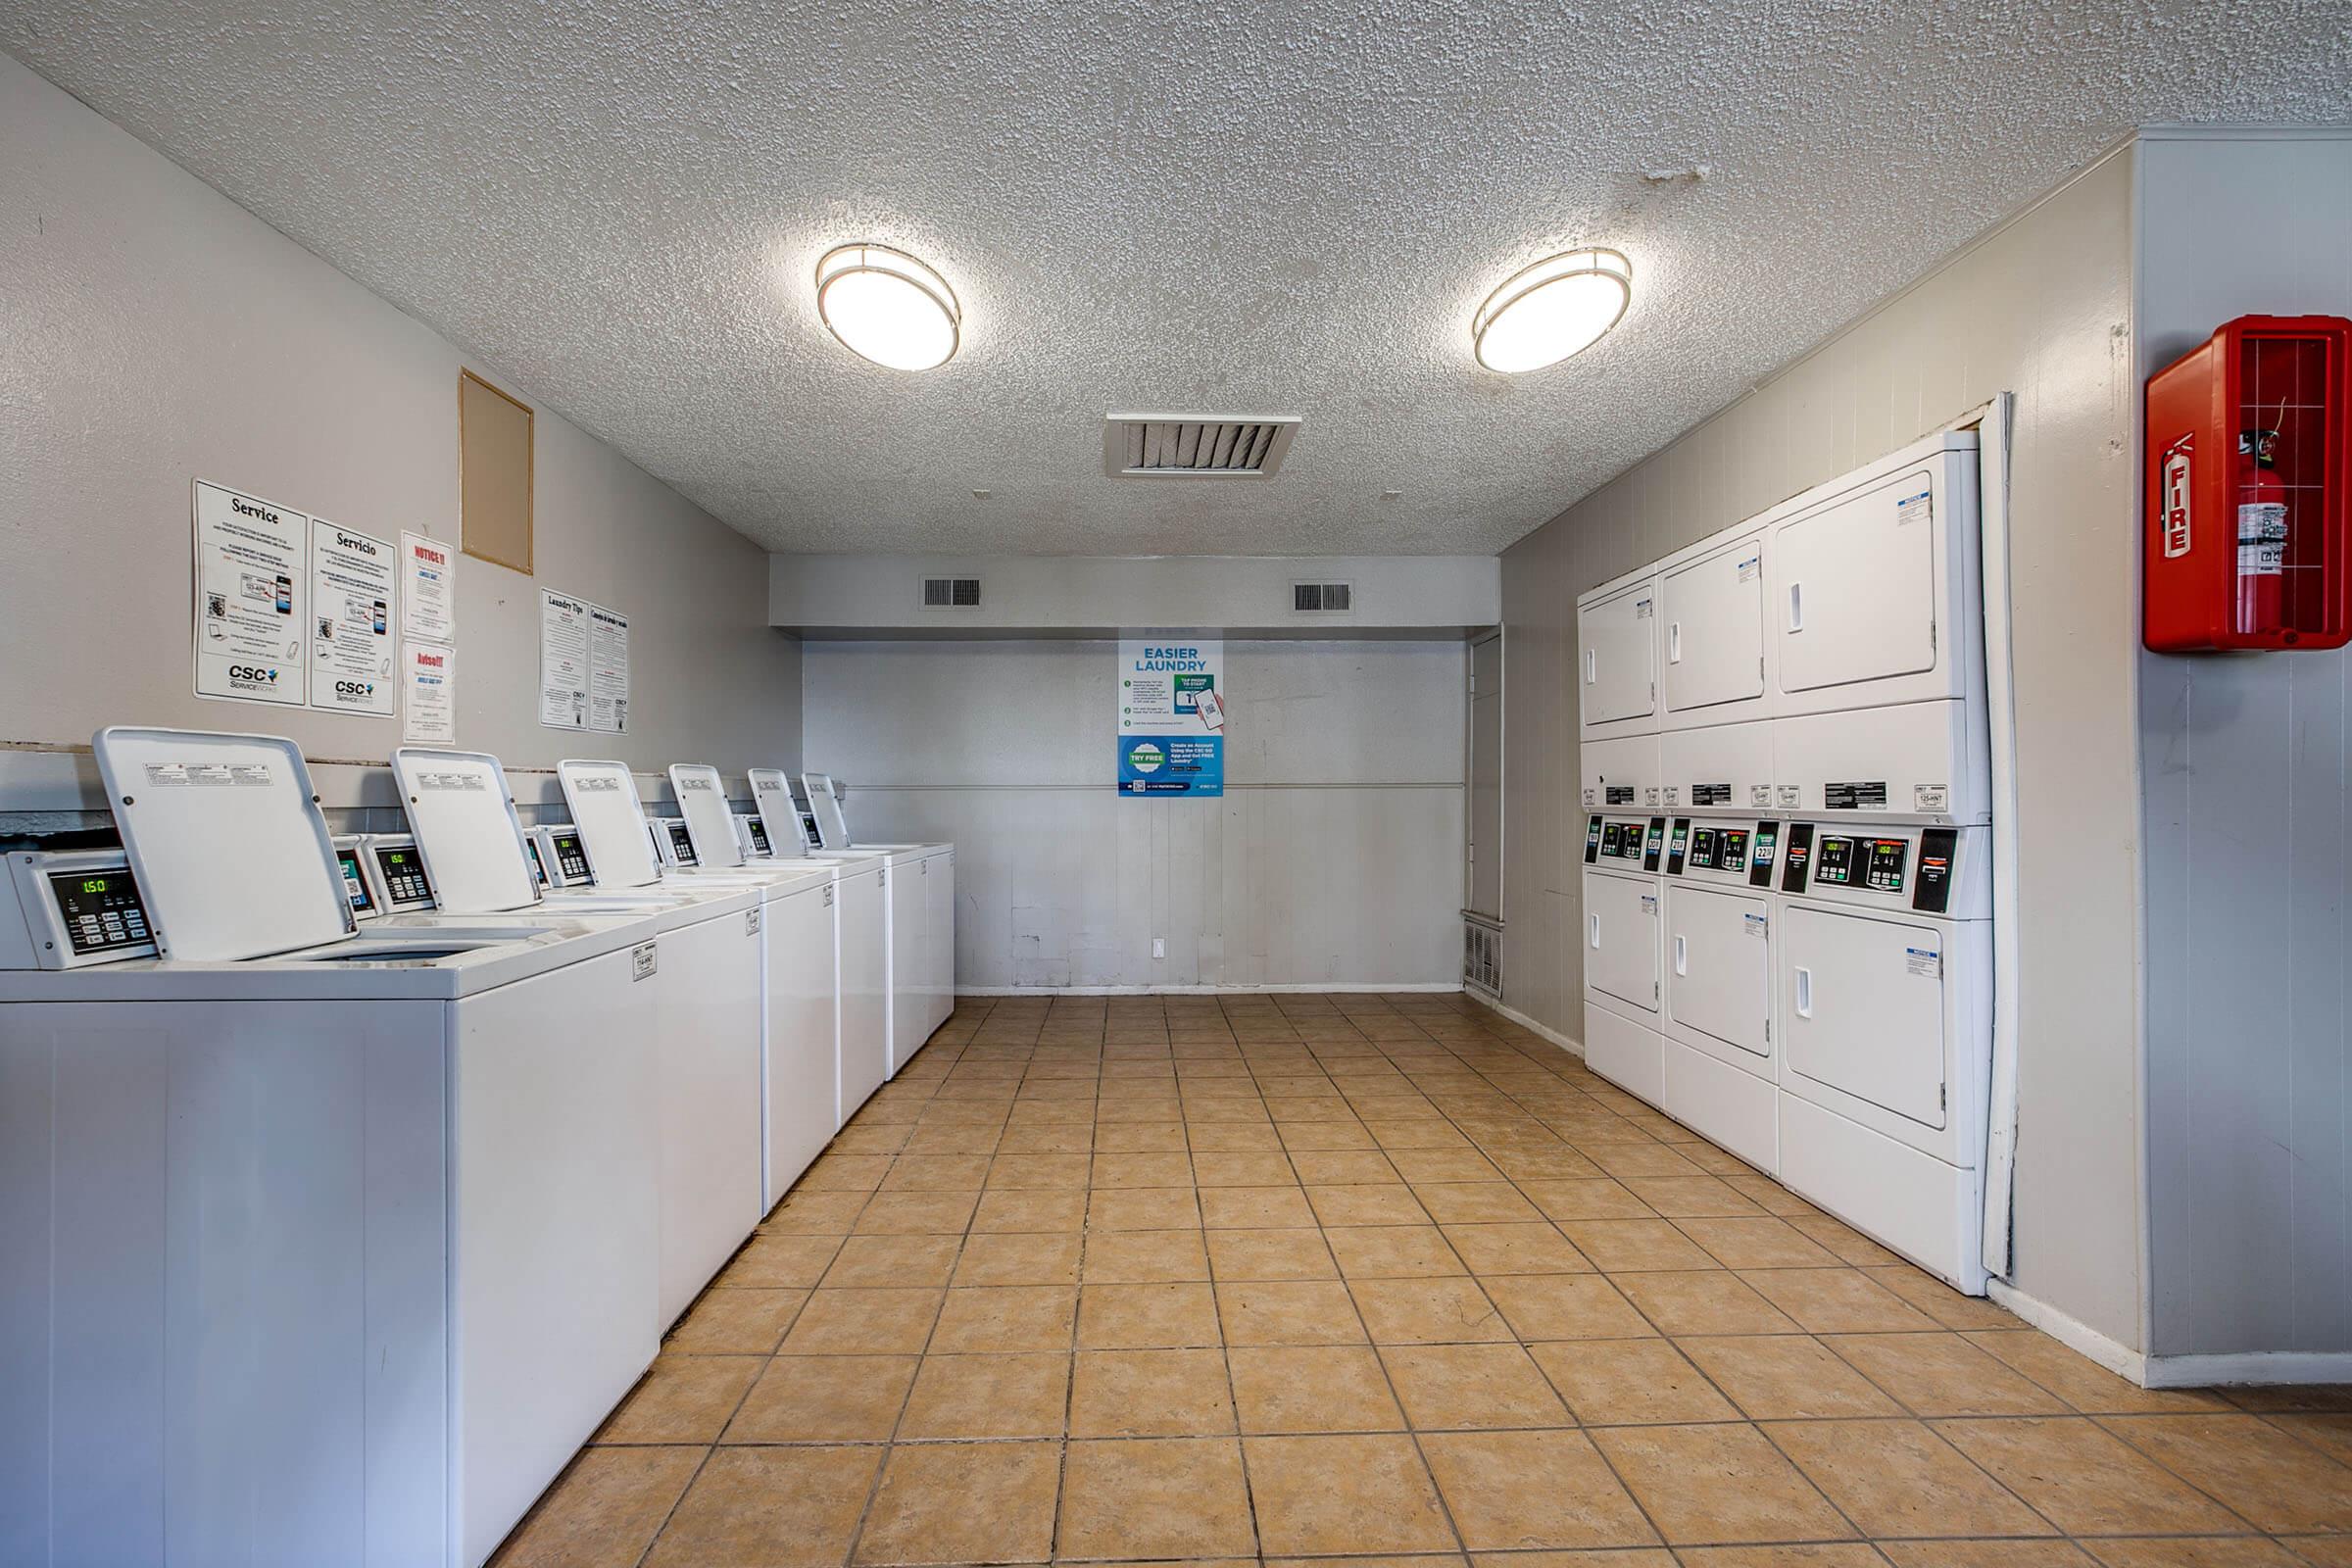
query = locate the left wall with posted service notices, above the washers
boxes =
[0,57,800,808]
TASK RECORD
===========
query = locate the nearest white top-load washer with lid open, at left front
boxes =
[0,729,659,1568]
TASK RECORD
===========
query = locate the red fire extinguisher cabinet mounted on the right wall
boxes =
[2142,315,2352,654]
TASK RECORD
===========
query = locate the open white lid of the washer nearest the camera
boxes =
[89,726,358,964]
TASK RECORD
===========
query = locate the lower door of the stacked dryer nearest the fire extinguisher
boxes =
[1781,906,1945,1128]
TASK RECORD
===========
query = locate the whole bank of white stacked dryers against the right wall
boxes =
[1578,432,1992,1293]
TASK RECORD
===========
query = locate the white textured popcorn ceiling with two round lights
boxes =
[0,0,2352,555]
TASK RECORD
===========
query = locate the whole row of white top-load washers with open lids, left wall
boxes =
[0,729,955,1568]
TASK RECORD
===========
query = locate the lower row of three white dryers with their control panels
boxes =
[1583,813,1992,1296]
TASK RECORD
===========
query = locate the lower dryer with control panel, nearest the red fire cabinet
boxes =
[1774,823,1992,1296]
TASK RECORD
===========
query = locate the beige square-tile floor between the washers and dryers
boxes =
[499,995,2352,1568]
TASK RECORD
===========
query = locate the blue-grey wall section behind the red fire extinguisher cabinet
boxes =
[2138,131,2352,1354]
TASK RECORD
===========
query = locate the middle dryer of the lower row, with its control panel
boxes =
[1658,815,1781,1171]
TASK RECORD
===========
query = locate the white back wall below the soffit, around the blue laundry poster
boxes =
[802,639,1468,987]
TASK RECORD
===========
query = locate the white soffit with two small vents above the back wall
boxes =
[769,555,1503,637]
